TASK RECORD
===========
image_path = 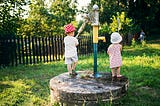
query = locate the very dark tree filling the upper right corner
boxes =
[128,0,160,33]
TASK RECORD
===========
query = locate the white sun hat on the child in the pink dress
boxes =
[111,32,122,43]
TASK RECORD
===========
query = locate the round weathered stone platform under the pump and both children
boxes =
[50,71,129,106]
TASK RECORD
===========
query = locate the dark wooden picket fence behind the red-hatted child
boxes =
[0,36,93,66]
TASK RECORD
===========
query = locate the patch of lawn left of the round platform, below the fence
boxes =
[0,62,66,106]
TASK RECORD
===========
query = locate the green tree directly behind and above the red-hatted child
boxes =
[49,0,76,34]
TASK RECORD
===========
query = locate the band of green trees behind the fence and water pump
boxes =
[0,0,160,37]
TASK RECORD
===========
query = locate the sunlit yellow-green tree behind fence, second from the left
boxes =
[20,0,49,36]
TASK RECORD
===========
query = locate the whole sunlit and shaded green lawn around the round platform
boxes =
[0,40,160,106]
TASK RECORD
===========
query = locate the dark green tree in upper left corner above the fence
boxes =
[0,0,27,37]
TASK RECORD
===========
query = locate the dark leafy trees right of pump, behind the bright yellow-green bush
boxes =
[91,0,160,35]
